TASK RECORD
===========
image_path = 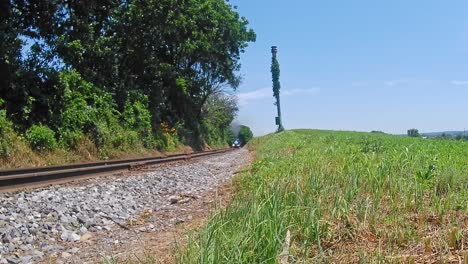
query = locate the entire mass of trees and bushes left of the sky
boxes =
[0,0,256,156]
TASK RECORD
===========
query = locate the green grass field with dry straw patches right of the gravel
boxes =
[178,130,468,263]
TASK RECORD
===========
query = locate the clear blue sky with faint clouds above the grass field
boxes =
[230,0,468,135]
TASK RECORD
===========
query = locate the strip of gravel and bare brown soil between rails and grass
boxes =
[0,149,249,263]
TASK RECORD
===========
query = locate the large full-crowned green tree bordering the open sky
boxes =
[91,0,256,134]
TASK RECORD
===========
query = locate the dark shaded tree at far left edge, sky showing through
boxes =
[0,0,64,128]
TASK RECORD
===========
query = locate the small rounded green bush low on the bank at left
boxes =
[26,125,57,151]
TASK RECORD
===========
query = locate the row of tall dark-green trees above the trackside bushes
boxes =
[0,0,256,151]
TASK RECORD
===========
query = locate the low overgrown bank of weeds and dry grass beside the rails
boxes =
[0,92,181,168]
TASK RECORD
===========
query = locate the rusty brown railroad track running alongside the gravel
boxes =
[0,149,231,190]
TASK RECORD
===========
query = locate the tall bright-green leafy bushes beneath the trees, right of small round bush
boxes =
[59,71,151,154]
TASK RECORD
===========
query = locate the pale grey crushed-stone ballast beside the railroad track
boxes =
[0,149,248,263]
